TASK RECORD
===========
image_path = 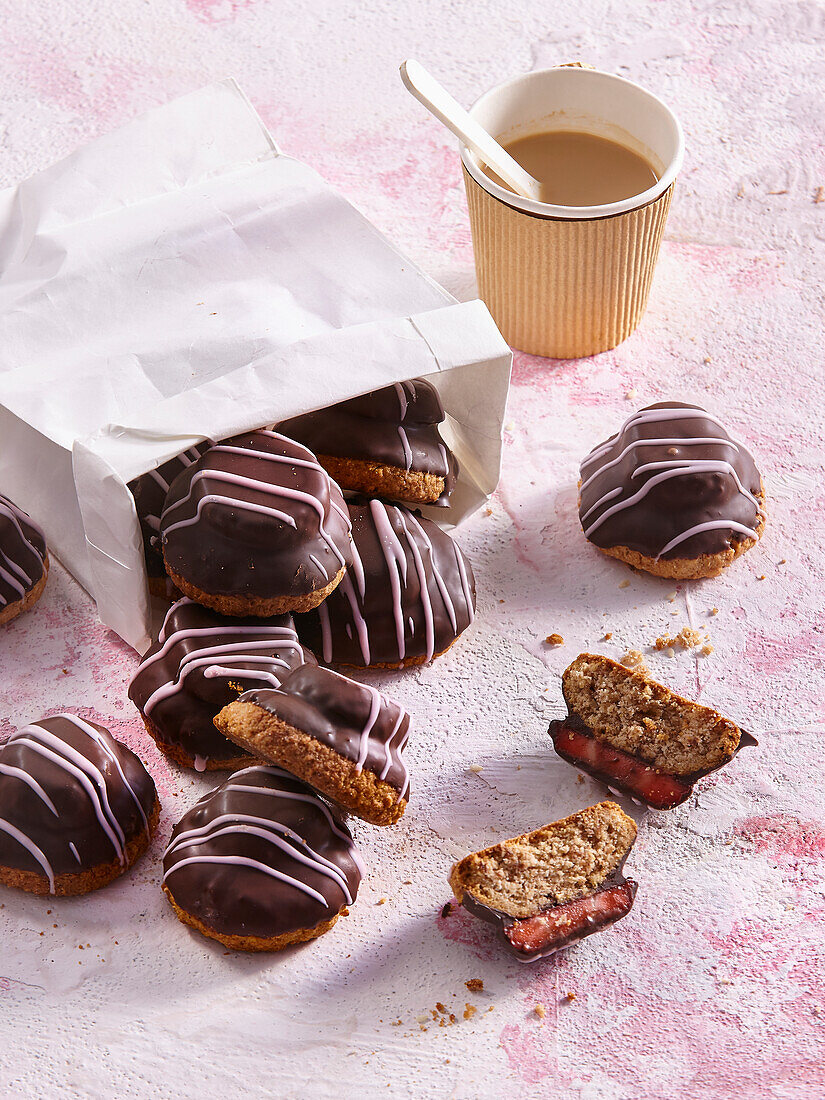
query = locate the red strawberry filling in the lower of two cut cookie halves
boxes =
[504,880,636,955]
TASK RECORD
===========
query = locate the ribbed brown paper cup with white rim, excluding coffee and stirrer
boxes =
[461,66,684,359]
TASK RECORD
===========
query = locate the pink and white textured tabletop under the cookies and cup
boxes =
[0,0,825,1100]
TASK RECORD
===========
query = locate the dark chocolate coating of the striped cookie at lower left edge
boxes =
[0,714,157,892]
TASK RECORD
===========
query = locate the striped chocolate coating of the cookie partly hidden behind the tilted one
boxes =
[129,598,316,763]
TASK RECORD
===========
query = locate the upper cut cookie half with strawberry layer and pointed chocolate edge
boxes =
[549,653,757,810]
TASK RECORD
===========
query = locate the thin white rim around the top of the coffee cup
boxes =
[461,66,684,221]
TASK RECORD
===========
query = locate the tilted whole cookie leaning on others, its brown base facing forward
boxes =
[215,664,409,825]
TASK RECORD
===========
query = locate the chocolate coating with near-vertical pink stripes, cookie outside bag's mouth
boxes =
[296,501,475,667]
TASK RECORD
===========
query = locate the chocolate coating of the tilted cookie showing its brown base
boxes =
[241,664,409,799]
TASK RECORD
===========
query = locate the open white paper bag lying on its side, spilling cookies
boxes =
[0,80,510,651]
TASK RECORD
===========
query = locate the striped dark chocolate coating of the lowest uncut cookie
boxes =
[163,767,364,938]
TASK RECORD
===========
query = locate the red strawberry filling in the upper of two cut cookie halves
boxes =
[550,722,693,810]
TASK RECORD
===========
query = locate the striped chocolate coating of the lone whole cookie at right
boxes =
[579,402,763,561]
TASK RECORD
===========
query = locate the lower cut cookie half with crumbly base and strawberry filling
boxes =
[450,802,636,963]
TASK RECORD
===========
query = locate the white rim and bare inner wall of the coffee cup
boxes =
[461,67,684,219]
